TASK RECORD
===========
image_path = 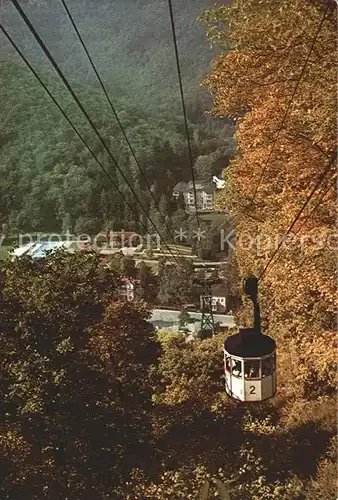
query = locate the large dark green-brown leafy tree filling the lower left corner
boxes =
[0,253,158,499]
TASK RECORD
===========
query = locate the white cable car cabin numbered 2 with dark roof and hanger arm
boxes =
[224,278,276,402]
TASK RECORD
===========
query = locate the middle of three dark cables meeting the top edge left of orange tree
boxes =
[61,0,180,250]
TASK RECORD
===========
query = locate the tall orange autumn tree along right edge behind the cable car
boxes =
[202,0,337,398]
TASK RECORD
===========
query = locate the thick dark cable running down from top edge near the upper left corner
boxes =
[11,0,184,265]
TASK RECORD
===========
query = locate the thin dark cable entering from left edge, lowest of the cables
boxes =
[0,24,182,272]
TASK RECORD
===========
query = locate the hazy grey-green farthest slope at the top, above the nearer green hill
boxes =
[2,0,229,111]
